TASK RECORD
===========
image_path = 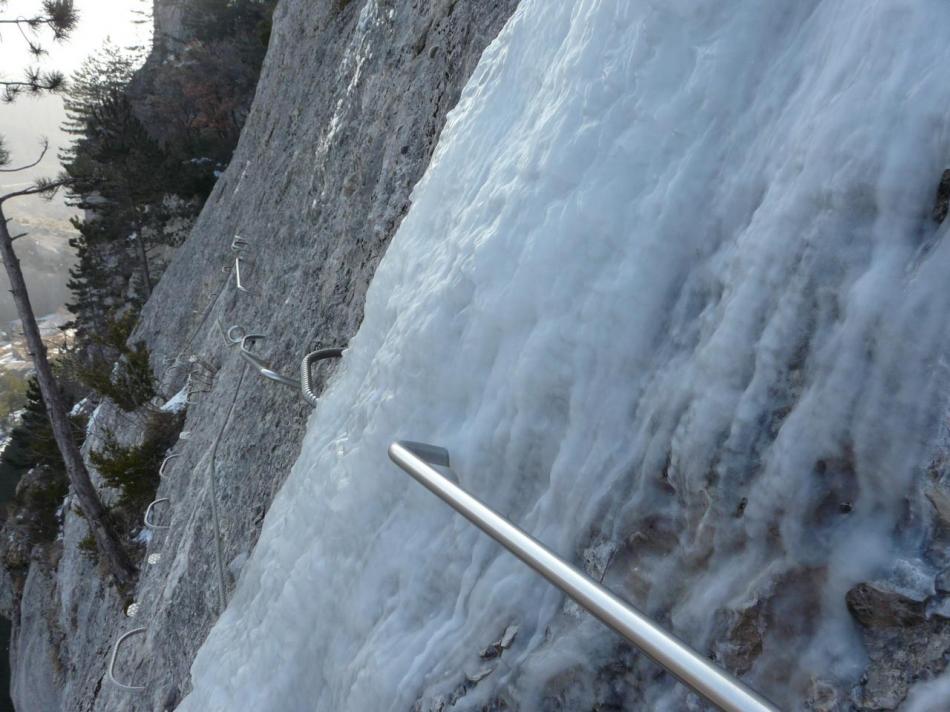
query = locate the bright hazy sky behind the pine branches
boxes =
[0,0,152,213]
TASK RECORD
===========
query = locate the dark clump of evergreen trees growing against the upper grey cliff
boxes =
[60,0,276,356]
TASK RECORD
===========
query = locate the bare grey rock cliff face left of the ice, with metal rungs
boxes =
[3,0,516,712]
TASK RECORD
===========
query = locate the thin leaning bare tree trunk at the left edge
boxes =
[0,200,136,589]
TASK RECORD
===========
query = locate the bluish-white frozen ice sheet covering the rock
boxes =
[179,0,950,712]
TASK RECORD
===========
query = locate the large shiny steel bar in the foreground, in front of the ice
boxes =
[389,441,778,712]
